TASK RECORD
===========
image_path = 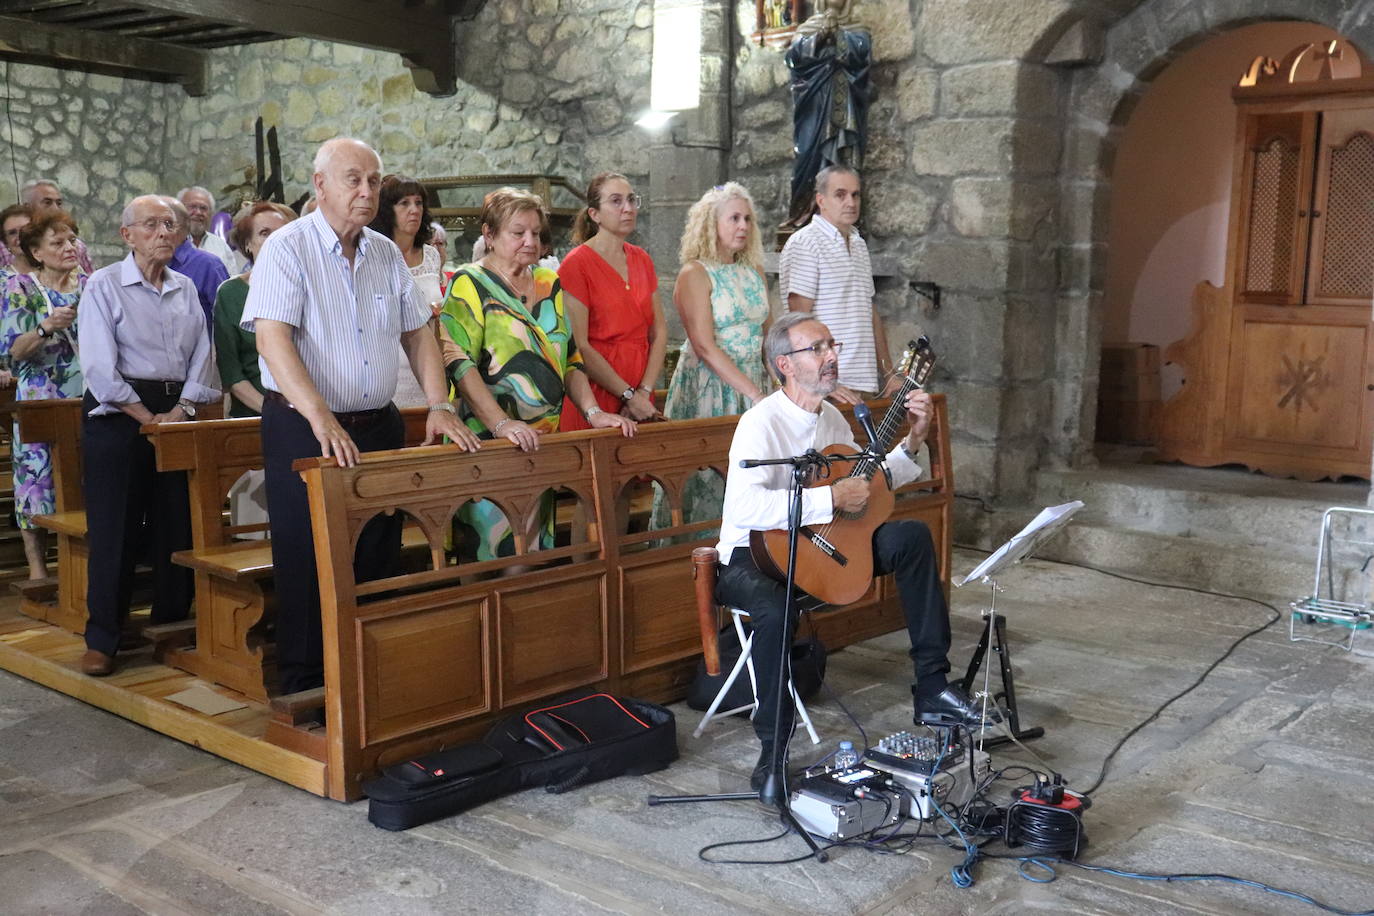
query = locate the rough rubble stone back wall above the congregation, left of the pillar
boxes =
[0,0,653,261]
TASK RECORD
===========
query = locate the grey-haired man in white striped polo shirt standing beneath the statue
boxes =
[778,165,900,404]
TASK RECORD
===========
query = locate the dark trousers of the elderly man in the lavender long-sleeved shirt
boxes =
[81,391,195,655]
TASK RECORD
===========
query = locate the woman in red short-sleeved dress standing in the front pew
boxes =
[558,172,668,431]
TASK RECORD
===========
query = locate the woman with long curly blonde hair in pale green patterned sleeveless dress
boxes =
[653,181,771,527]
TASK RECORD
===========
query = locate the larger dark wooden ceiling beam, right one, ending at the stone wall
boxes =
[123,0,485,95]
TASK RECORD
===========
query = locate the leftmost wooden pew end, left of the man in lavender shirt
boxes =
[15,398,89,633]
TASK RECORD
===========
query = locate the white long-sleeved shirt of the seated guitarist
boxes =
[716,390,921,566]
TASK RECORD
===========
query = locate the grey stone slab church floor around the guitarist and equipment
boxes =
[0,552,1374,916]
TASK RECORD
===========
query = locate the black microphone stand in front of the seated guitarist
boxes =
[649,449,830,862]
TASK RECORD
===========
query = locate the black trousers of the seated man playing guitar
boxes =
[716,520,949,740]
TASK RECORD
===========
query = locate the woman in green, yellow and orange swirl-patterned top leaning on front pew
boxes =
[440,188,635,560]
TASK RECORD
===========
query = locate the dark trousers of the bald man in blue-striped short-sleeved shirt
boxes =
[261,397,405,694]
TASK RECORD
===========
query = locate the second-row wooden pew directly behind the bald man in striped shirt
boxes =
[143,408,426,700]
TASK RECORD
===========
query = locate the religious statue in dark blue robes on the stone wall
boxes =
[786,0,872,225]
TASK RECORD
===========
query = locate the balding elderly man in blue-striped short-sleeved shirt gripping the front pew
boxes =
[242,137,480,694]
